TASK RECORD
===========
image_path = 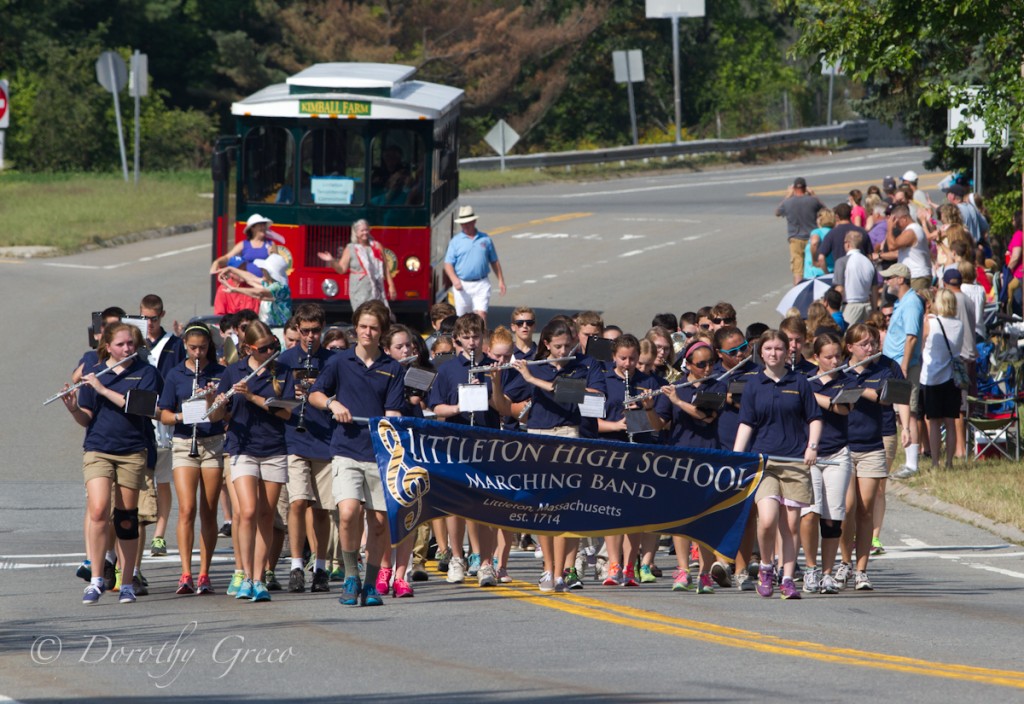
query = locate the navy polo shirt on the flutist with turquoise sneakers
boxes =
[217,357,295,457]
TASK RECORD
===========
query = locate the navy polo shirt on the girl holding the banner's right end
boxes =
[739,369,821,457]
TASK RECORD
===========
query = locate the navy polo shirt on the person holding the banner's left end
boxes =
[309,348,405,461]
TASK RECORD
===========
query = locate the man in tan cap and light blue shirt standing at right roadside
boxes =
[882,260,925,479]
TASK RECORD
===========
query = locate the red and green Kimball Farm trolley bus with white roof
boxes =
[211,63,464,315]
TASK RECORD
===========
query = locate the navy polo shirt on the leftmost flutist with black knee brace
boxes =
[78,357,164,454]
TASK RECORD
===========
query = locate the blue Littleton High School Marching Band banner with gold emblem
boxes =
[370,417,763,559]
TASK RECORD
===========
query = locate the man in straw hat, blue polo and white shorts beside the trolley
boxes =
[444,206,505,320]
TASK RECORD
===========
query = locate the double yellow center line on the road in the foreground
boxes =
[468,581,1024,689]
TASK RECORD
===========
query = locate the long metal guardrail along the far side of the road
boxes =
[459,120,867,171]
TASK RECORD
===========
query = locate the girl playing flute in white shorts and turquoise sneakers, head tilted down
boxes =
[205,320,295,602]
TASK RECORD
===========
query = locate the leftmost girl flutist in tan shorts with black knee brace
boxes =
[61,322,163,606]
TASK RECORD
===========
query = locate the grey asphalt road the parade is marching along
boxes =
[0,149,1024,703]
